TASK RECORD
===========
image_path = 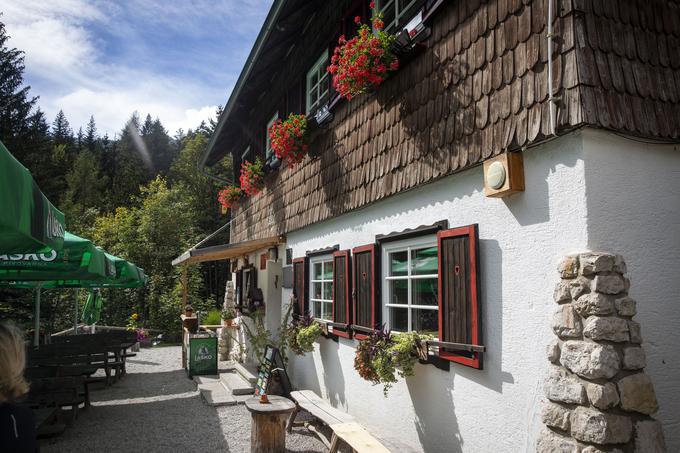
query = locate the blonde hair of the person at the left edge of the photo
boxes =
[0,322,28,403]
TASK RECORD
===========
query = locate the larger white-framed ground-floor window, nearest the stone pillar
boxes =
[381,236,439,335]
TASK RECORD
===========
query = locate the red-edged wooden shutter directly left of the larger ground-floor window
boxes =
[352,244,380,340]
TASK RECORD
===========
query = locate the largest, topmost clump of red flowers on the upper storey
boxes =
[328,2,399,99]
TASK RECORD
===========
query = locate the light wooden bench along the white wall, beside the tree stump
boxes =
[288,390,389,453]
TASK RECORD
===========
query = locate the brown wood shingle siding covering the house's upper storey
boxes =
[219,0,680,242]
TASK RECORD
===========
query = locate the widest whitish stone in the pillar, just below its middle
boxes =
[560,340,620,379]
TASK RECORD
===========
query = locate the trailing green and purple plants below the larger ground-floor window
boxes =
[354,326,432,397]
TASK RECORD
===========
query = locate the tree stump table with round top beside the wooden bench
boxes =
[246,395,295,453]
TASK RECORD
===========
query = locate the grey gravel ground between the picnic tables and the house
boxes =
[41,346,326,453]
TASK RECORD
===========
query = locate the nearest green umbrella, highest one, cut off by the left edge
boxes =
[0,142,65,253]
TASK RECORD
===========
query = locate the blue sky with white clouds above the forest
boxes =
[0,0,272,136]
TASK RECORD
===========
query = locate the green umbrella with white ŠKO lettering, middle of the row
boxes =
[0,232,116,282]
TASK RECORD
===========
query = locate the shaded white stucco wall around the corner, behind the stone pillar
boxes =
[583,131,680,452]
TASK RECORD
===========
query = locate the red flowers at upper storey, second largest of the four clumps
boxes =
[269,113,309,167]
